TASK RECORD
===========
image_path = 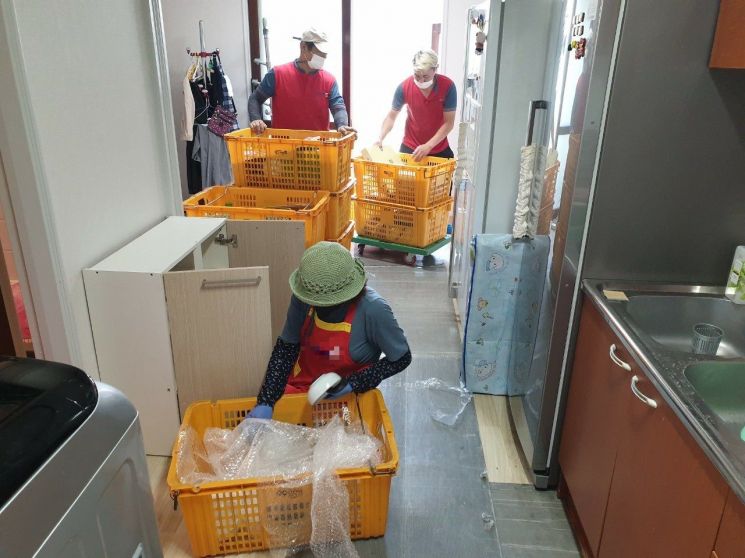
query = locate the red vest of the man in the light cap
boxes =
[272,62,336,130]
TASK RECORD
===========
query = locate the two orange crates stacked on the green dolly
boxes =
[354,153,456,253]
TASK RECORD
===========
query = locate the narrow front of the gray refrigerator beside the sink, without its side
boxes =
[509,0,624,488]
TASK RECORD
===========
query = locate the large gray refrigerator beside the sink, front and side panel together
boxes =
[509,0,745,488]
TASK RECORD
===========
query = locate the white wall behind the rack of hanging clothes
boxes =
[161,0,251,196]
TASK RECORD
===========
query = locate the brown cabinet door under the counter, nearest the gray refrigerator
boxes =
[559,300,633,556]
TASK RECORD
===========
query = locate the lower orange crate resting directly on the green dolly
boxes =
[354,198,452,248]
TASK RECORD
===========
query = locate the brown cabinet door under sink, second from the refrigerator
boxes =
[598,371,727,558]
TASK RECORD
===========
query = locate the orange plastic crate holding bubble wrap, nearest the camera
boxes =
[168,390,398,556]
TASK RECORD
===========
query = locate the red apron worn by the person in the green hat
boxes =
[285,302,370,393]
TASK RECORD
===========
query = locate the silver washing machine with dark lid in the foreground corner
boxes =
[0,357,163,558]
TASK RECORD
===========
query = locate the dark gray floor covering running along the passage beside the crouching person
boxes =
[340,247,579,558]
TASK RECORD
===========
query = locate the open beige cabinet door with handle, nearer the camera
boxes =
[163,267,272,420]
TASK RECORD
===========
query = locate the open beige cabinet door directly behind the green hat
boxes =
[228,221,305,339]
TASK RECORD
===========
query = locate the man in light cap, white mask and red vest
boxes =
[248,27,354,134]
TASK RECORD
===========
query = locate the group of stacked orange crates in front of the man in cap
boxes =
[184,128,355,247]
